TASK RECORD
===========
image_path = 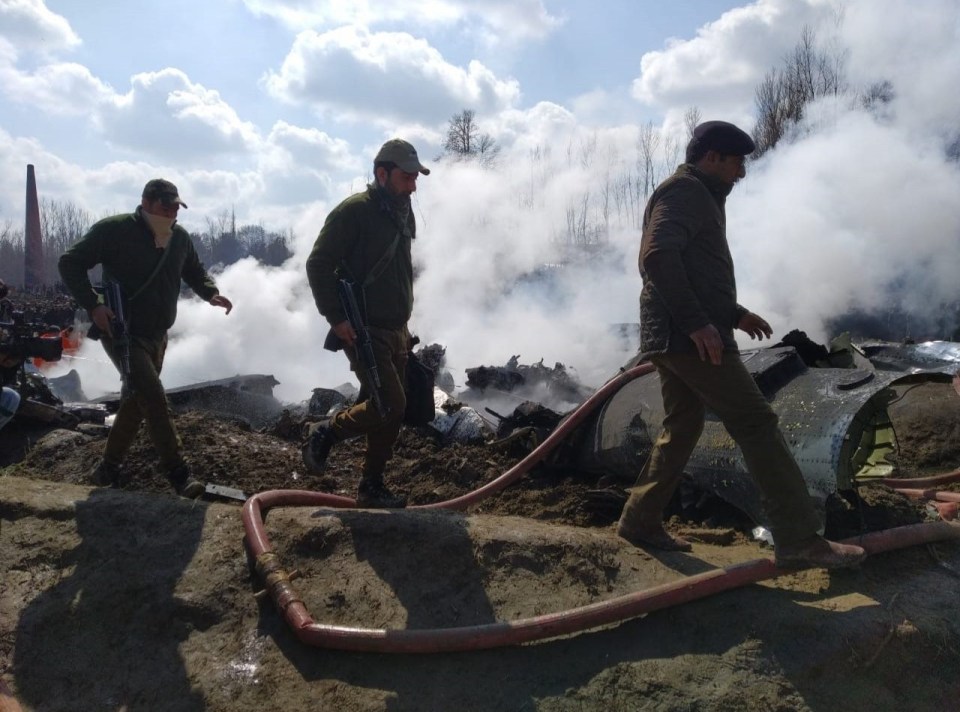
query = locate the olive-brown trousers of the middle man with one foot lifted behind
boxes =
[330,326,410,482]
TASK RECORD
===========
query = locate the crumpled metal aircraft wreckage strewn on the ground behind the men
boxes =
[1,322,960,526]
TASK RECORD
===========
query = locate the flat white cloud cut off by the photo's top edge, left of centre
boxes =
[237,0,563,41]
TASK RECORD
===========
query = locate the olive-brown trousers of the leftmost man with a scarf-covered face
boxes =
[100,335,183,472]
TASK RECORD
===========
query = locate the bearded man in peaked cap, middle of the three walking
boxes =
[302,138,430,508]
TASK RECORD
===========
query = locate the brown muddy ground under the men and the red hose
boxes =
[0,376,960,712]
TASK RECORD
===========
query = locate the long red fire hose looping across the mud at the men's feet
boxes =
[242,364,960,653]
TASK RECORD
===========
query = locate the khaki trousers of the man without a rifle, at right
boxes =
[621,353,820,546]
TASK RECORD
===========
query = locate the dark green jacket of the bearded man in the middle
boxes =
[307,186,417,329]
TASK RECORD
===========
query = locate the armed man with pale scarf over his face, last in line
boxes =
[58,178,233,499]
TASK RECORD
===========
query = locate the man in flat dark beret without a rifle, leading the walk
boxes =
[617,121,865,568]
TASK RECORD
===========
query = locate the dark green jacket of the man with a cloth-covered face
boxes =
[58,207,219,339]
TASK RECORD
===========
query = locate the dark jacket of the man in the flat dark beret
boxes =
[639,163,747,354]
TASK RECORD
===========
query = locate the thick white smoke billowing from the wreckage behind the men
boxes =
[48,0,960,408]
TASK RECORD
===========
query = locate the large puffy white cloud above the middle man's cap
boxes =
[263,27,520,126]
